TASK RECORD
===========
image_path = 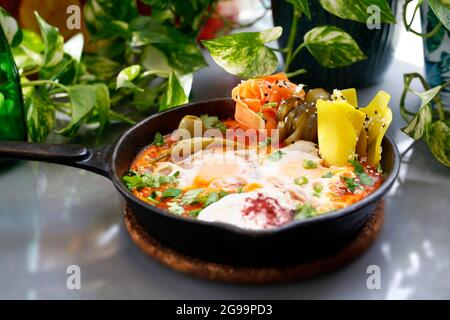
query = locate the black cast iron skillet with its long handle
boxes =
[0,99,399,266]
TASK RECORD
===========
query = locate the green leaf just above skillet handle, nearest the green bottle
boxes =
[25,92,56,143]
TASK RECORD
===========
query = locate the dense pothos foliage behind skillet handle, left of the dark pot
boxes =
[0,0,218,142]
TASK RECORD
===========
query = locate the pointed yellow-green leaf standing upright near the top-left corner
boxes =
[34,12,64,67]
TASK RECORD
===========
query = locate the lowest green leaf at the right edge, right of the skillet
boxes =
[427,121,450,167]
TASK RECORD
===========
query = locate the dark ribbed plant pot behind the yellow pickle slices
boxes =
[272,0,397,89]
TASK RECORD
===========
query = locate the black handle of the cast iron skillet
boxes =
[0,141,111,178]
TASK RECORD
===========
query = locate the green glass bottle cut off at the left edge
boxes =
[0,26,27,145]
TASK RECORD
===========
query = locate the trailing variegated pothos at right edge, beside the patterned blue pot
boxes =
[400,0,450,167]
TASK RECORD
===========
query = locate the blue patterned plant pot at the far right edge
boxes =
[420,2,450,107]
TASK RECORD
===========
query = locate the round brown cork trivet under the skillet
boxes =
[125,201,384,284]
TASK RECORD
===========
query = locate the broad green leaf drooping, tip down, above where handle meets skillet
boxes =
[58,84,96,136]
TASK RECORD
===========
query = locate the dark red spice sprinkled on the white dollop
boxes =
[242,193,293,228]
